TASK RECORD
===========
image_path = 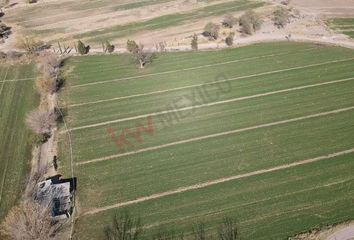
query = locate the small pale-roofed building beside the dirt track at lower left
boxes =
[36,175,76,218]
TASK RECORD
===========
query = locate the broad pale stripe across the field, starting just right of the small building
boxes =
[81,148,354,216]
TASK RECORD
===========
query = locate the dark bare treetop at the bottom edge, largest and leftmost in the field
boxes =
[105,212,143,240]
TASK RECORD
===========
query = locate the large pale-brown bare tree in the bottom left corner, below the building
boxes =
[0,201,63,240]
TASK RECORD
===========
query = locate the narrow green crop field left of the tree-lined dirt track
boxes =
[0,64,38,220]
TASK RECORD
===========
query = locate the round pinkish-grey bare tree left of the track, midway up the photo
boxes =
[26,108,58,135]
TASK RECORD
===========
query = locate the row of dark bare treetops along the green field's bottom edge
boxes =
[105,212,238,240]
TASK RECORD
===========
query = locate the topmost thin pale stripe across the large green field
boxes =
[71,47,320,88]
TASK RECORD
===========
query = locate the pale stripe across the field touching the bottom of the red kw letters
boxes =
[76,106,354,166]
